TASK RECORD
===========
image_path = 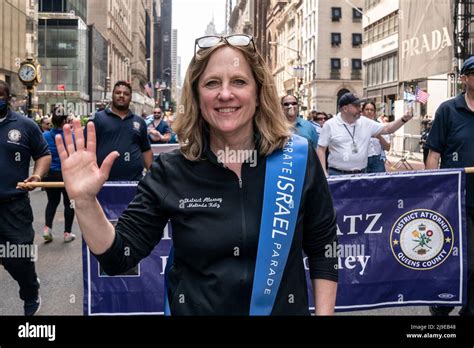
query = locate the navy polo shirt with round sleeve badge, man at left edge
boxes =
[0,110,50,199]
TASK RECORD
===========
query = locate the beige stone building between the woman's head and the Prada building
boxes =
[264,0,363,113]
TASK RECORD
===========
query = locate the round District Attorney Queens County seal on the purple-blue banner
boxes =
[390,209,454,270]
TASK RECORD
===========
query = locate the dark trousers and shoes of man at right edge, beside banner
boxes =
[430,207,474,316]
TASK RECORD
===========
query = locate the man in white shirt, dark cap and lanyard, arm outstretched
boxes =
[317,92,413,175]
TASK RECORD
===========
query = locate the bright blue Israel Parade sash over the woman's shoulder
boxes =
[250,135,308,315]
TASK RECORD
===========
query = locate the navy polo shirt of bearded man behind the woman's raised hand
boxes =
[92,109,151,181]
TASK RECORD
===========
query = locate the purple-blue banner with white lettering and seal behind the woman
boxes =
[83,170,467,315]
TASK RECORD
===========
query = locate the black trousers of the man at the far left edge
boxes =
[0,194,39,301]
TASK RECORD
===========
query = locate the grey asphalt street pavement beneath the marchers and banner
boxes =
[0,163,458,316]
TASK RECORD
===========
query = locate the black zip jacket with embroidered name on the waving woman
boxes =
[97,141,337,315]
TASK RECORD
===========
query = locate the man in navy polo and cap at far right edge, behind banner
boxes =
[426,56,474,315]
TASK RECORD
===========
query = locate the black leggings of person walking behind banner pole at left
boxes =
[44,171,74,232]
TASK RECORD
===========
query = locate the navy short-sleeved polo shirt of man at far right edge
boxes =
[426,93,474,207]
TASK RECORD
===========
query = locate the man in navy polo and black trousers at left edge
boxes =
[0,81,51,315]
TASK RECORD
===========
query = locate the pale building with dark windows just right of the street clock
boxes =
[37,0,90,114]
